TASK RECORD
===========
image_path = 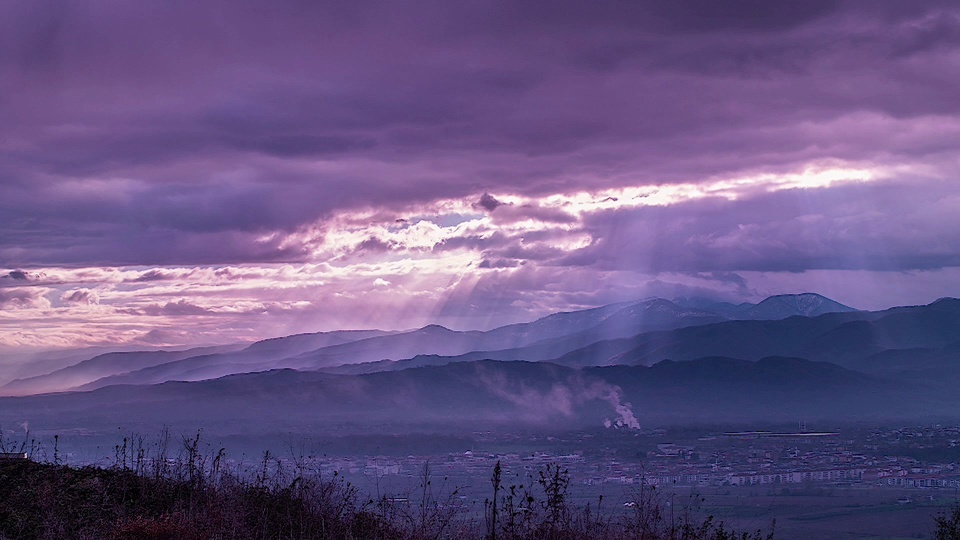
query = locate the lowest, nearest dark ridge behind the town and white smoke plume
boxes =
[0,357,948,434]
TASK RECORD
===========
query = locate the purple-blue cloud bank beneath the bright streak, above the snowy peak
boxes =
[558,177,960,273]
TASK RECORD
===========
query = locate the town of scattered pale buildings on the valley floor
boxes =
[306,425,960,504]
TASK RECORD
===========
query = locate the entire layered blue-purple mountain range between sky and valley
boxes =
[0,293,960,440]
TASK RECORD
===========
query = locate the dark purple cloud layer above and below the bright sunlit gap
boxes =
[0,0,960,280]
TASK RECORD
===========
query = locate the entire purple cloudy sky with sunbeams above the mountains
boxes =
[0,0,960,350]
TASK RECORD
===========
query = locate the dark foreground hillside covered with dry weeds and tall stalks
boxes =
[0,456,773,540]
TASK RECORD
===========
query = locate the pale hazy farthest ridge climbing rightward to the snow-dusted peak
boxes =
[4,294,868,394]
